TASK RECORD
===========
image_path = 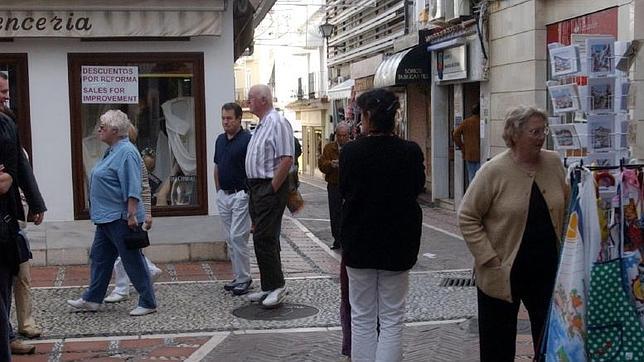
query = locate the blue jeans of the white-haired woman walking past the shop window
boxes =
[83,220,157,308]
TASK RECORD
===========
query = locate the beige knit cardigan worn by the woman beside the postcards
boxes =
[458,150,569,302]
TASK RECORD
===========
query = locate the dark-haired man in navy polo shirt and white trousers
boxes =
[214,103,253,295]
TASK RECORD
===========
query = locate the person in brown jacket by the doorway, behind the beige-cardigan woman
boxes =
[452,104,481,185]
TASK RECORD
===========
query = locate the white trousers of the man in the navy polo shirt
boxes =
[217,190,251,283]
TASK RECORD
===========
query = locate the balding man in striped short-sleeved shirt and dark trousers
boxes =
[246,84,295,308]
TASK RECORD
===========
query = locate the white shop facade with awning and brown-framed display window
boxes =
[0,0,266,264]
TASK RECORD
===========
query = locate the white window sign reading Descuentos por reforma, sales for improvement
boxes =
[81,65,139,104]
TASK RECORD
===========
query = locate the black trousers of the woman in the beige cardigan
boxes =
[477,263,557,362]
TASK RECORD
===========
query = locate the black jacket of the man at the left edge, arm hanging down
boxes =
[0,111,47,220]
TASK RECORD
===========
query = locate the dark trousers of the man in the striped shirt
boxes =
[248,179,288,291]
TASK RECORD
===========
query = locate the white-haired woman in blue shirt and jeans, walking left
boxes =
[67,110,156,316]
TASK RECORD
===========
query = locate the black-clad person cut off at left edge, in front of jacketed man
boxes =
[0,136,20,361]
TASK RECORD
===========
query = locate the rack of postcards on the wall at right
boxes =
[546,34,639,166]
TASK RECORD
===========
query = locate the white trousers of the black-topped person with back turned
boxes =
[347,267,409,362]
